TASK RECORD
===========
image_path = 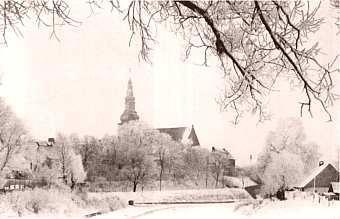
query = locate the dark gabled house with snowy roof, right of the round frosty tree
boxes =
[294,163,339,193]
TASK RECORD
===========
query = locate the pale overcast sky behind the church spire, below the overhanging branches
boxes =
[0,2,340,165]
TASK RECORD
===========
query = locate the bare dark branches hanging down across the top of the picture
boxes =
[0,0,339,122]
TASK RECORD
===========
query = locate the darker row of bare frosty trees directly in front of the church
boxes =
[56,122,234,191]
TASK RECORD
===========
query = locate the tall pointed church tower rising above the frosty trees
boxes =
[119,79,139,125]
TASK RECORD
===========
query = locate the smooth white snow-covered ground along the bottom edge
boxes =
[94,199,340,219]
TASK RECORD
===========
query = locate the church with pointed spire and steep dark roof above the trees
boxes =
[119,79,200,146]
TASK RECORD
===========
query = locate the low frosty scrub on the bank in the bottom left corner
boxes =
[0,188,124,218]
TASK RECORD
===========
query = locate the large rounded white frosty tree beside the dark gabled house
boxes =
[257,118,320,198]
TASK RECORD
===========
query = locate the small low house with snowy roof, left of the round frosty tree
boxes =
[223,176,261,198]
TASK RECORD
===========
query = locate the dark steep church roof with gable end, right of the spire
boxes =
[157,125,200,146]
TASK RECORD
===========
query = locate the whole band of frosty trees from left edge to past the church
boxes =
[0,98,234,191]
